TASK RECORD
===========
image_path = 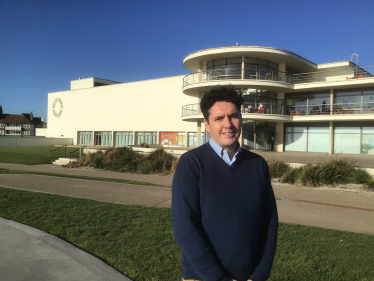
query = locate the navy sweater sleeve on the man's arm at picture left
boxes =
[171,156,231,281]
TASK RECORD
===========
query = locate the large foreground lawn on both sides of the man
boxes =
[0,188,374,281]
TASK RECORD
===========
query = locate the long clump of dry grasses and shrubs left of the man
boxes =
[66,147,178,174]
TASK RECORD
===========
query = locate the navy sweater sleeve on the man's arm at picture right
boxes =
[250,162,278,281]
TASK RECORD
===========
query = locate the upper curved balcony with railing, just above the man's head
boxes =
[183,68,293,96]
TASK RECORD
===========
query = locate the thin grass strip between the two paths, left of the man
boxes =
[0,168,170,187]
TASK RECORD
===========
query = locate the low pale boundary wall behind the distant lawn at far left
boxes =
[0,136,73,147]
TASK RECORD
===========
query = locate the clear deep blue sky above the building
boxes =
[0,0,374,121]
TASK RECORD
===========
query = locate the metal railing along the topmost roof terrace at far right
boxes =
[291,66,374,84]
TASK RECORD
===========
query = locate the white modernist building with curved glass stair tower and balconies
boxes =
[47,46,374,154]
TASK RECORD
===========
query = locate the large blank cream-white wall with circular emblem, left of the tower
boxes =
[47,76,198,144]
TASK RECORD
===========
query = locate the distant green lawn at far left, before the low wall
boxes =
[0,146,76,165]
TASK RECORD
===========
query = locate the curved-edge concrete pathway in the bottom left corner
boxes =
[0,218,131,281]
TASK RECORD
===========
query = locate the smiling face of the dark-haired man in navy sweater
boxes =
[204,101,242,151]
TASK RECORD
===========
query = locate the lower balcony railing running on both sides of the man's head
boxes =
[182,102,374,117]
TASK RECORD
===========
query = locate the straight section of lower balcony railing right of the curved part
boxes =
[285,102,374,116]
